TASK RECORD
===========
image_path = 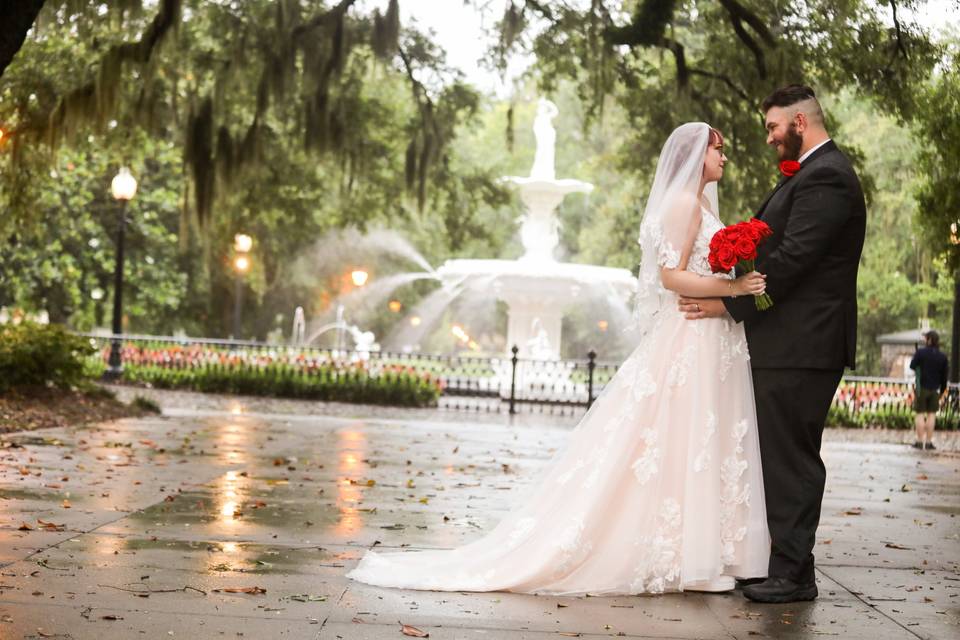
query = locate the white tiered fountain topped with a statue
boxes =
[437,99,636,360]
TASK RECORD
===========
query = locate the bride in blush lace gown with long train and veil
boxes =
[347,122,770,595]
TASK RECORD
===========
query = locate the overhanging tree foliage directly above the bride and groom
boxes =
[506,0,940,229]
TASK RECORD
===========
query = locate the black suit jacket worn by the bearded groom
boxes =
[723,140,867,370]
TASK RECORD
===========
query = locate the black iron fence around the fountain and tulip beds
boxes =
[79,334,960,429]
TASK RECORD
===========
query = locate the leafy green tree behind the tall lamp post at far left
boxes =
[0,130,188,330]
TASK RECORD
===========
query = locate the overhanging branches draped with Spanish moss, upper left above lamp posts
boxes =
[8,0,477,228]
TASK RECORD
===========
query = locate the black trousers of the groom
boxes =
[753,369,843,583]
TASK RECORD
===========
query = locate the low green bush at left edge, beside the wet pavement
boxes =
[0,322,93,392]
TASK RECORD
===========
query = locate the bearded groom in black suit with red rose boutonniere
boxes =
[680,85,866,602]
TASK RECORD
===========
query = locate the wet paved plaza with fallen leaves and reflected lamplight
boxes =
[0,390,960,640]
